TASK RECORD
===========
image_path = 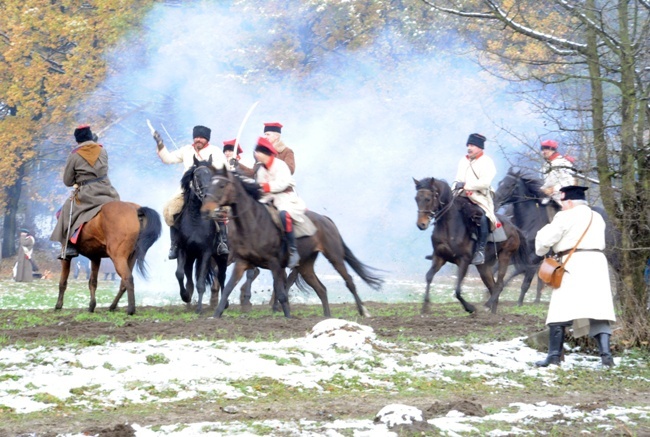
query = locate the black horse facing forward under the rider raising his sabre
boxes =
[176,156,228,314]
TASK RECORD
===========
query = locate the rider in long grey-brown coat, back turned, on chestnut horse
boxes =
[50,124,120,259]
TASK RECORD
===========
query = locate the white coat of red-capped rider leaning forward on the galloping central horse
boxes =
[255,157,307,216]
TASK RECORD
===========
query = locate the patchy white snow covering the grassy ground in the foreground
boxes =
[0,319,650,437]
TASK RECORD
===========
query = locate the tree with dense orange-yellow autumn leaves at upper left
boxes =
[0,0,152,257]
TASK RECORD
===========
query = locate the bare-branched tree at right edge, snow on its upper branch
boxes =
[423,0,650,345]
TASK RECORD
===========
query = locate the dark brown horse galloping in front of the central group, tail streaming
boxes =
[196,169,383,318]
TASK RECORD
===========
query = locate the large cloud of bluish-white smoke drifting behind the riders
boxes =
[69,2,544,296]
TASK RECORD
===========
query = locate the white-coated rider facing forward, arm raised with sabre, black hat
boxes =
[153,126,228,259]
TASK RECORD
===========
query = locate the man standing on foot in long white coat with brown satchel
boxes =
[535,185,616,367]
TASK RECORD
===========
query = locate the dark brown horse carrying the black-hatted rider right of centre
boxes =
[413,177,527,314]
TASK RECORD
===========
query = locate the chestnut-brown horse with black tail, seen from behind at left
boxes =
[54,201,162,315]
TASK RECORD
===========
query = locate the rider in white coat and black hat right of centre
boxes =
[452,134,498,265]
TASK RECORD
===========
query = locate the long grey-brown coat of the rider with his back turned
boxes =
[50,141,120,245]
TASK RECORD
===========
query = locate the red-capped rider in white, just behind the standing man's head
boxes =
[541,140,576,209]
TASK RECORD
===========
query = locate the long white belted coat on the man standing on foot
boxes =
[535,205,616,330]
